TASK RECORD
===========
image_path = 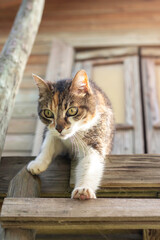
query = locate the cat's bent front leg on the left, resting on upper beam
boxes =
[27,131,62,175]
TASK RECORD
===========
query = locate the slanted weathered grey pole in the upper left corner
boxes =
[0,0,44,160]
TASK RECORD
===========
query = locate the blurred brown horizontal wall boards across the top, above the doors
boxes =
[0,0,160,46]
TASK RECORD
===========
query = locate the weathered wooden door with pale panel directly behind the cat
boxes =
[72,48,144,154]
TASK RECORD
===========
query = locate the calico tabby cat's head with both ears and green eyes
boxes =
[33,70,96,139]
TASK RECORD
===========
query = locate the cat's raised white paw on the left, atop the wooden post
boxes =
[27,158,48,175]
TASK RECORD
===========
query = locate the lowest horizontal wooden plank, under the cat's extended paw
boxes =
[0,198,160,233]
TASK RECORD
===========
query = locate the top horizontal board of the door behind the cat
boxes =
[75,47,138,61]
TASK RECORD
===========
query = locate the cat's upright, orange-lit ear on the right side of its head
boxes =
[70,70,92,95]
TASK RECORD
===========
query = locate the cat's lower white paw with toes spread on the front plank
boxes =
[71,187,96,200]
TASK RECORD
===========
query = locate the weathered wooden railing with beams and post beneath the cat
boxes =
[0,155,160,240]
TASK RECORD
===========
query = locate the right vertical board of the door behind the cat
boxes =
[124,56,144,154]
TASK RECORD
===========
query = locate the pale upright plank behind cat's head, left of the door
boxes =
[32,40,74,155]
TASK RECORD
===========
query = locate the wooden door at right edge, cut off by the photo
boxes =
[141,48,160,153]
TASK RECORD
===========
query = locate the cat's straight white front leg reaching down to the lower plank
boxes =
[71,149,104,200]
